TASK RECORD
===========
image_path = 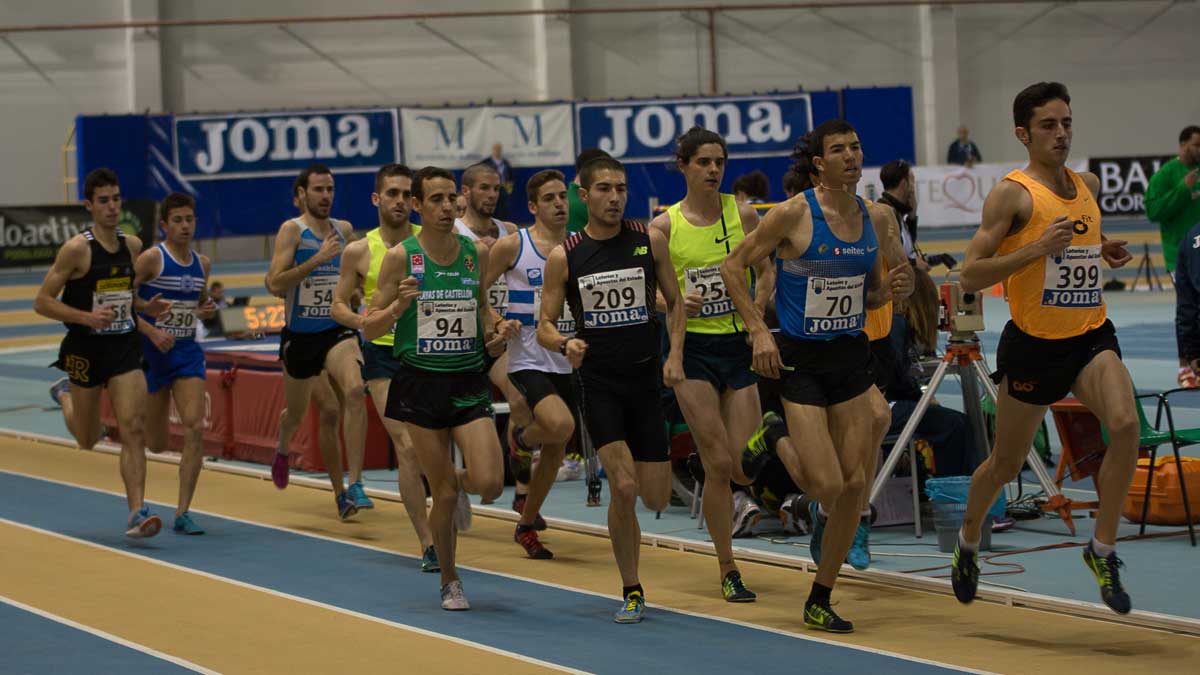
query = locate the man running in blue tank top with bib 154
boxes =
[266,165,374,520]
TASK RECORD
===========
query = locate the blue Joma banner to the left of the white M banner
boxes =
[175,109,400,180]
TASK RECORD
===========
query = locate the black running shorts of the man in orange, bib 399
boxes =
[991,321,1121,406]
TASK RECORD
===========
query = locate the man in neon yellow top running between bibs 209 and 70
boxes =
[650,126,775,602]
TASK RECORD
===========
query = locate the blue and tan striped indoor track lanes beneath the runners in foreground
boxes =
[0,436,1200,675]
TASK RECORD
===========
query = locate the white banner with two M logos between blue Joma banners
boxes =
[400,103,575,168]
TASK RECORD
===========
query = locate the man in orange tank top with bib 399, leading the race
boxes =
[950,82,1139,614]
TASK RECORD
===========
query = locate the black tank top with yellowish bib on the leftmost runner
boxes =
[62,229,137,335]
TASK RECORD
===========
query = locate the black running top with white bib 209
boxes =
[563,220,659,370]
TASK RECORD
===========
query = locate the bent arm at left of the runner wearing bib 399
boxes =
[959,180,1074,293]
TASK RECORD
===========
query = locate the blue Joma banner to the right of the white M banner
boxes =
[575,94,812,162]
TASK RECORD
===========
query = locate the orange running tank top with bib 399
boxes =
[996,168,1106,340]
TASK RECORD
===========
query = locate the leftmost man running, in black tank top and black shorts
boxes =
[34,168,167,538]
